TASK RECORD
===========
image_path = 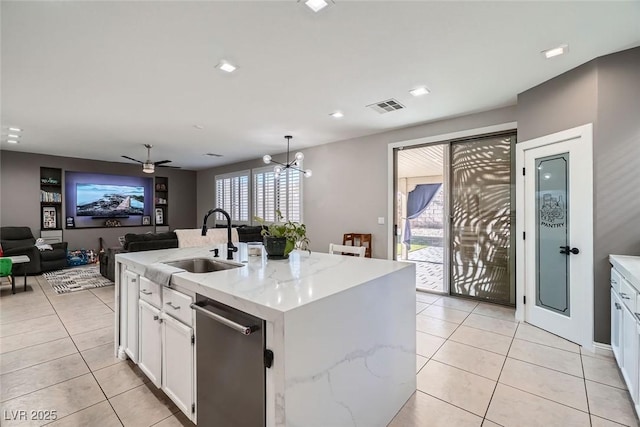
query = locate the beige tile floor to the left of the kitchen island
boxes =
[0,276,193,427]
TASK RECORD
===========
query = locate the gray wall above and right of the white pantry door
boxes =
[518,48,640,343]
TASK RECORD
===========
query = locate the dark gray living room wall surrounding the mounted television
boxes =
[0,150,197,249]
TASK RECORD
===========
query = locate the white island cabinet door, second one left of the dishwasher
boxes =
[138,301,162,387]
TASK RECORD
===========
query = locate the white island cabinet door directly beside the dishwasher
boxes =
[162,314,195,420]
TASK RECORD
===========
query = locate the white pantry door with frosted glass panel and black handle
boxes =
[516,124,593,349]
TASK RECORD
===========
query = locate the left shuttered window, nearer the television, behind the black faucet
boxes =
[216,170,250,223]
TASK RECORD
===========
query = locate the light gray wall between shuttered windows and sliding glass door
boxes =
[198,107,516,258]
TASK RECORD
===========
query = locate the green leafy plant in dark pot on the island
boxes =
[254,210,311,259]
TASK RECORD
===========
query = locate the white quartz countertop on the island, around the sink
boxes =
[116,243,413,319]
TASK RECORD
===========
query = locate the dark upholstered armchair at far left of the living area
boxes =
[0,227,69,275]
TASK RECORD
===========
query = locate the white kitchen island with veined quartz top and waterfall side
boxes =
[115,244,416,427]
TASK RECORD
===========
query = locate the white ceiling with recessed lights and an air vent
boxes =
[1,0,640,169]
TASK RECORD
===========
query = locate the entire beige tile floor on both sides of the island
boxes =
[0,276,638,427]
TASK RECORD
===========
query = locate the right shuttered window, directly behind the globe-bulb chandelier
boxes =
[253,167,302,222]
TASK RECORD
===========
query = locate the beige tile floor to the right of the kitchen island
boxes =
[391,293,638,427]
